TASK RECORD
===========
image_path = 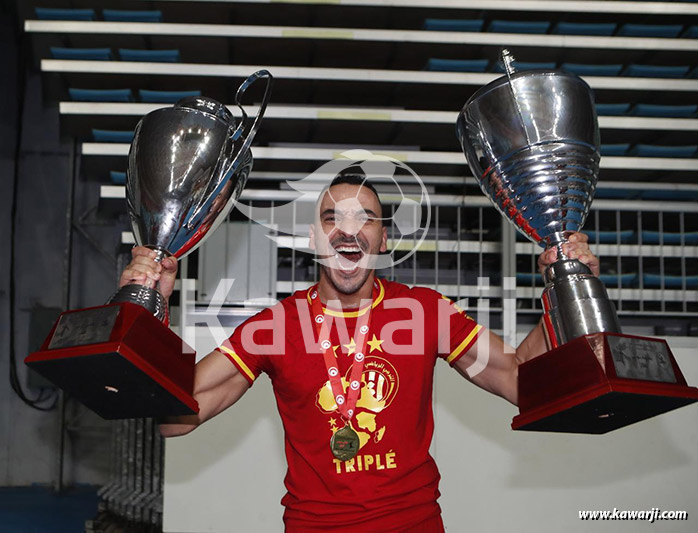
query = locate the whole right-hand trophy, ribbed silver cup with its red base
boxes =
[457,50,698,433]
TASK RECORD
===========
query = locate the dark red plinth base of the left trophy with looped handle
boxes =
[25,303,199,419]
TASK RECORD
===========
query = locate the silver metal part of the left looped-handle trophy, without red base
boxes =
[109,70,272,322]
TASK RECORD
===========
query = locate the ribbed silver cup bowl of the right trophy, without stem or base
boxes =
[457,60,599,246]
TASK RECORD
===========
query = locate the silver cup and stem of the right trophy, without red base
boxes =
[457,51,621,348]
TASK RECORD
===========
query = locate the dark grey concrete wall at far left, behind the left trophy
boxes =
[0,7,112,486]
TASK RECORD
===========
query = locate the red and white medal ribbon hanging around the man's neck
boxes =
[310,281,378,425]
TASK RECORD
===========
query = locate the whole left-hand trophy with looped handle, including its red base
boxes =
[26,70,272,418]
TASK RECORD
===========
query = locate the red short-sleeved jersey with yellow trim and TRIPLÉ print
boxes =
[219,280,481,532]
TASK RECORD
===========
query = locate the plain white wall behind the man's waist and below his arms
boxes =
[164,339,698,533]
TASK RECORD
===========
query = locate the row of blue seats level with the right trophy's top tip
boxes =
[425,58,698,78]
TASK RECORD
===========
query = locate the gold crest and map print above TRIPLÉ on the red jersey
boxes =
[315,356,399,449]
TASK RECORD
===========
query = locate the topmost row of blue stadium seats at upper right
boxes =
[423,18,698,39]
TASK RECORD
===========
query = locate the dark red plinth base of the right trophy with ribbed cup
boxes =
[511,333,698,434]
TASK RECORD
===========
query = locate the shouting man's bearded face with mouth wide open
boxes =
[310,184,387,294]
